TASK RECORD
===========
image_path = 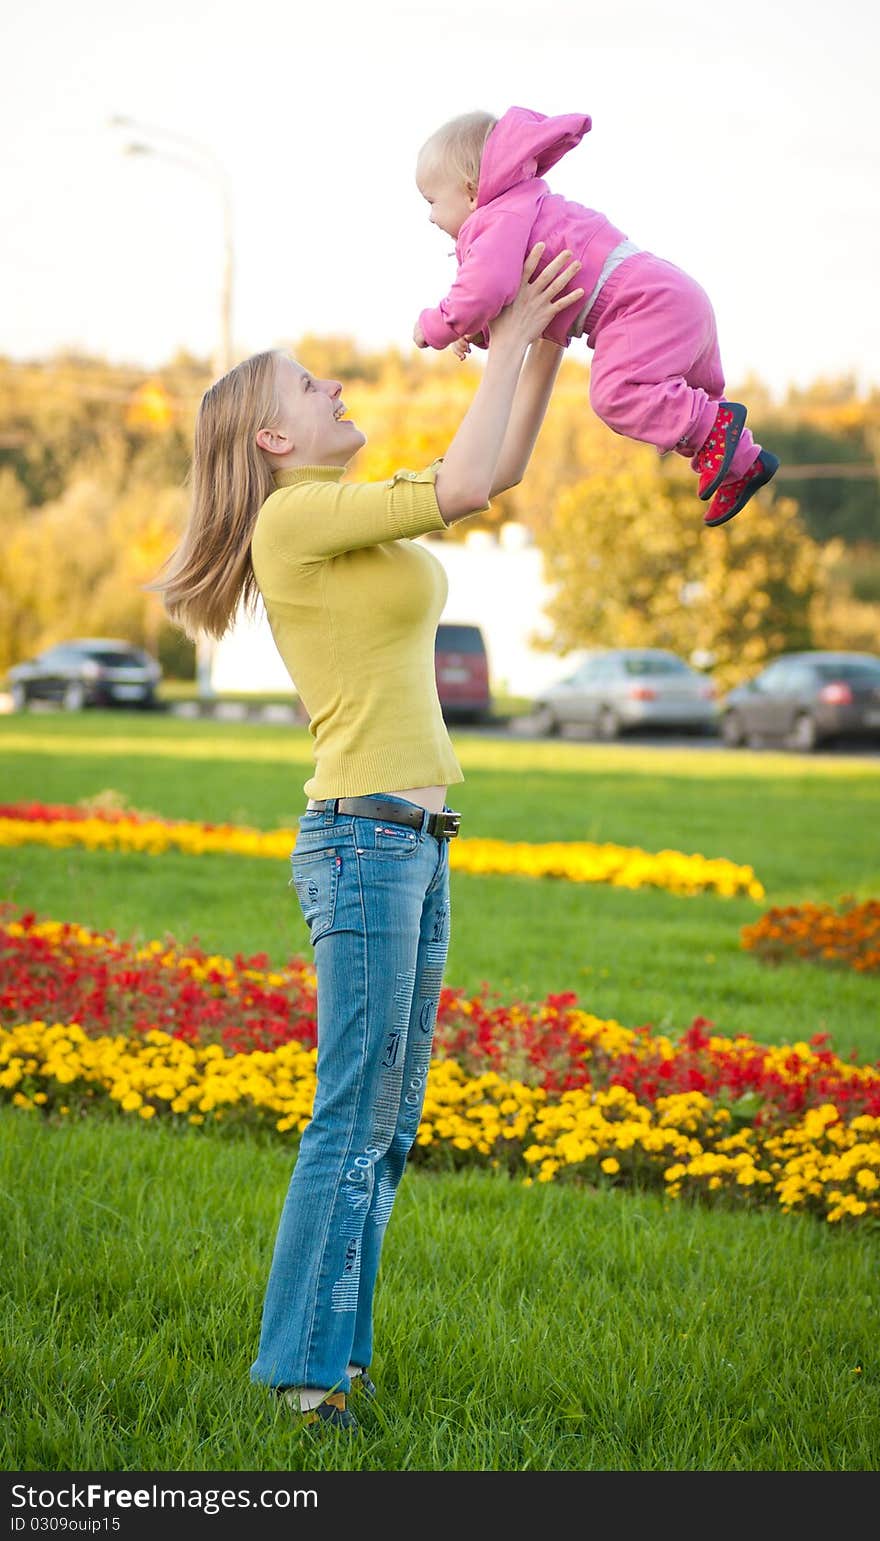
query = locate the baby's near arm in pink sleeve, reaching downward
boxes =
[416,213,532,348]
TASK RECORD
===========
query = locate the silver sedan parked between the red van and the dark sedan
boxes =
[532,647,717,738]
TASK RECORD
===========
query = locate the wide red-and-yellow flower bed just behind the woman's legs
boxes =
[0,912,880,1224]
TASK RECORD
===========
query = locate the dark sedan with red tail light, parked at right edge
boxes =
[720,650,880,750]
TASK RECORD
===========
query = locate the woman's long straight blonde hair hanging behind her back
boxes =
[145,351,282,638]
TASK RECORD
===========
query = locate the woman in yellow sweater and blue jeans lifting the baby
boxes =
[156,247,583,1430]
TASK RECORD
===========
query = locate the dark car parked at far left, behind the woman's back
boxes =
[6,636,162,712]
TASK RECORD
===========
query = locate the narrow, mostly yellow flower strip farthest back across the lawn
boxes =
[0,800,764,900]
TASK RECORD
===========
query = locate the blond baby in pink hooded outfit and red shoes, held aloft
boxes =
[413,106,780,525]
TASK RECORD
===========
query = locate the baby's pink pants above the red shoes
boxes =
[587,251,760,481]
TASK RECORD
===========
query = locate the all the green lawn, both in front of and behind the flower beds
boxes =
[0,713,880,1472]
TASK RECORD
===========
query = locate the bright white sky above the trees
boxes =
[0,0,880,393]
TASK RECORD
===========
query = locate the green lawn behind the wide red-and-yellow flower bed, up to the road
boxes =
[0,713,880,1059]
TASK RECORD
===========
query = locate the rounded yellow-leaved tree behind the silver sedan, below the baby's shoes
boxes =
[538,445,838,687]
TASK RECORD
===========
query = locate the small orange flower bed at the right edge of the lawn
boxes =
[741,898,880,974]
